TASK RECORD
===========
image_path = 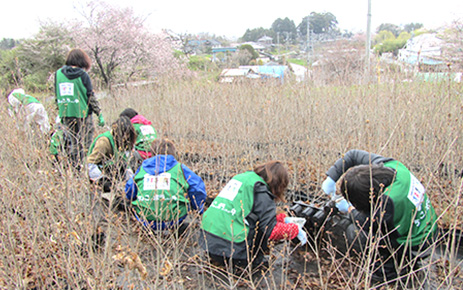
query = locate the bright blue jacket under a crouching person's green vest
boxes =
[125,155,207,230]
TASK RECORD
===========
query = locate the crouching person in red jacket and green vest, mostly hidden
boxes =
[120,108,158,168]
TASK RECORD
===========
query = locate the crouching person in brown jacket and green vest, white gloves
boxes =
[87,117,137,192]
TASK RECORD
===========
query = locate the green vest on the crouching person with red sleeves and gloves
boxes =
[201,171,267,243]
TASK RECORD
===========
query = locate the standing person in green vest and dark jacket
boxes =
[55,48,105,166]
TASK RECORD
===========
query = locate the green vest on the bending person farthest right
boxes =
[384,160,437,246]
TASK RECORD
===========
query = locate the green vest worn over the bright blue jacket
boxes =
[132,163,189,222]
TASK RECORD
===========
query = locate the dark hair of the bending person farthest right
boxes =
[341,164,395,214]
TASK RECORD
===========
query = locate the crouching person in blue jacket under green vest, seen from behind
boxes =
[125,139,206,235]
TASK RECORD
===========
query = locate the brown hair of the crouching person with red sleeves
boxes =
[254,160,289,202]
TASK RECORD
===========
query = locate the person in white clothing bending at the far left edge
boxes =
[7,88,50,134]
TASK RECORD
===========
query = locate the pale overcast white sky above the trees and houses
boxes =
[0,0,463,39]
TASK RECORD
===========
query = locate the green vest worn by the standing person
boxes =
[56,68,88,118]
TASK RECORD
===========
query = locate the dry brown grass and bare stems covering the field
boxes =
[0,76,463,289]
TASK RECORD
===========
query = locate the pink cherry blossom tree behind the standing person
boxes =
[71,1,186,88]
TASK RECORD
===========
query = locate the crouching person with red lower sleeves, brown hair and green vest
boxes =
[200,161,307,267]
